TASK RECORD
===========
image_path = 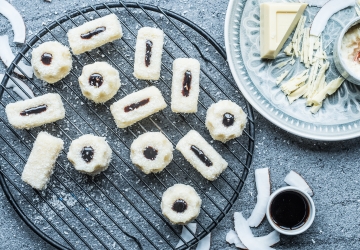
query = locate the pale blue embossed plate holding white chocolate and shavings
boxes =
[225,0,360,141]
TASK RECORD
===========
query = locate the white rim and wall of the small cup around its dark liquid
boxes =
[266,186,315,235]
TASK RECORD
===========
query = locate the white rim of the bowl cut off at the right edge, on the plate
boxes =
[333,17,360,85]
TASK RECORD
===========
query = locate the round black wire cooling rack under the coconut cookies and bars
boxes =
[0,2,255,249]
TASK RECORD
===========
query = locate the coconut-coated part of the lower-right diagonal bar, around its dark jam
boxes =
[176,130,228,181]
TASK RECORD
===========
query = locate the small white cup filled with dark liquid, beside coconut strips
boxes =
[266,186,315,235]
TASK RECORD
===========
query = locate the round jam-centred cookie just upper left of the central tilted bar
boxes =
[79,62,121,103]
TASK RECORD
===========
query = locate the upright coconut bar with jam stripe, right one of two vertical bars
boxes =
[171,58,200,113]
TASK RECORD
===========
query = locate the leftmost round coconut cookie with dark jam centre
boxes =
[31,41,72,83]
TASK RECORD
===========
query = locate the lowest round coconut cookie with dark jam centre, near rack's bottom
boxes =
[161,184,201,225]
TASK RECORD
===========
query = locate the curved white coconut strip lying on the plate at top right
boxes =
[310,0,355,36]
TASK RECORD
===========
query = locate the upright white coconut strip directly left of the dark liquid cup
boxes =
[247,168,270,227]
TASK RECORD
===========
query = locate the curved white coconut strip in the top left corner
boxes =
[0,0,26,43]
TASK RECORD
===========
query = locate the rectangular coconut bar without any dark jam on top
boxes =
[21,132,64,190]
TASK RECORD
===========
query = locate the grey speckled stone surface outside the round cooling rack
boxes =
[0,0,360,250]
